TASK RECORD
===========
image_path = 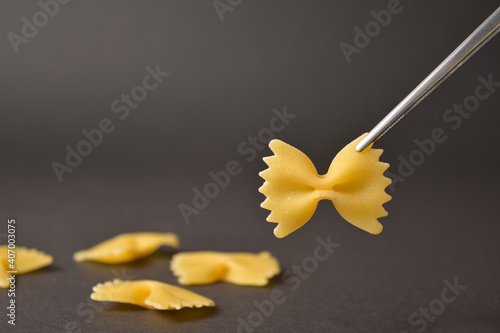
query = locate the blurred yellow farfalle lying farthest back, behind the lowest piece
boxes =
[73,232,179,264]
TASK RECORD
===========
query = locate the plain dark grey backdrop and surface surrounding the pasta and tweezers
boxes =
[0,0,500,333]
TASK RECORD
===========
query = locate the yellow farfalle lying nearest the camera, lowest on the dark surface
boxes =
[90,279,215,310]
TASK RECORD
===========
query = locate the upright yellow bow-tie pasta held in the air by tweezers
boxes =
[259,134,391,238]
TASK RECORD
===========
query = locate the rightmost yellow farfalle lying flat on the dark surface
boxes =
[170,251,280,286]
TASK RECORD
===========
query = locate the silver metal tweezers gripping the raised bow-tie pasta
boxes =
[356,7,500,152]
